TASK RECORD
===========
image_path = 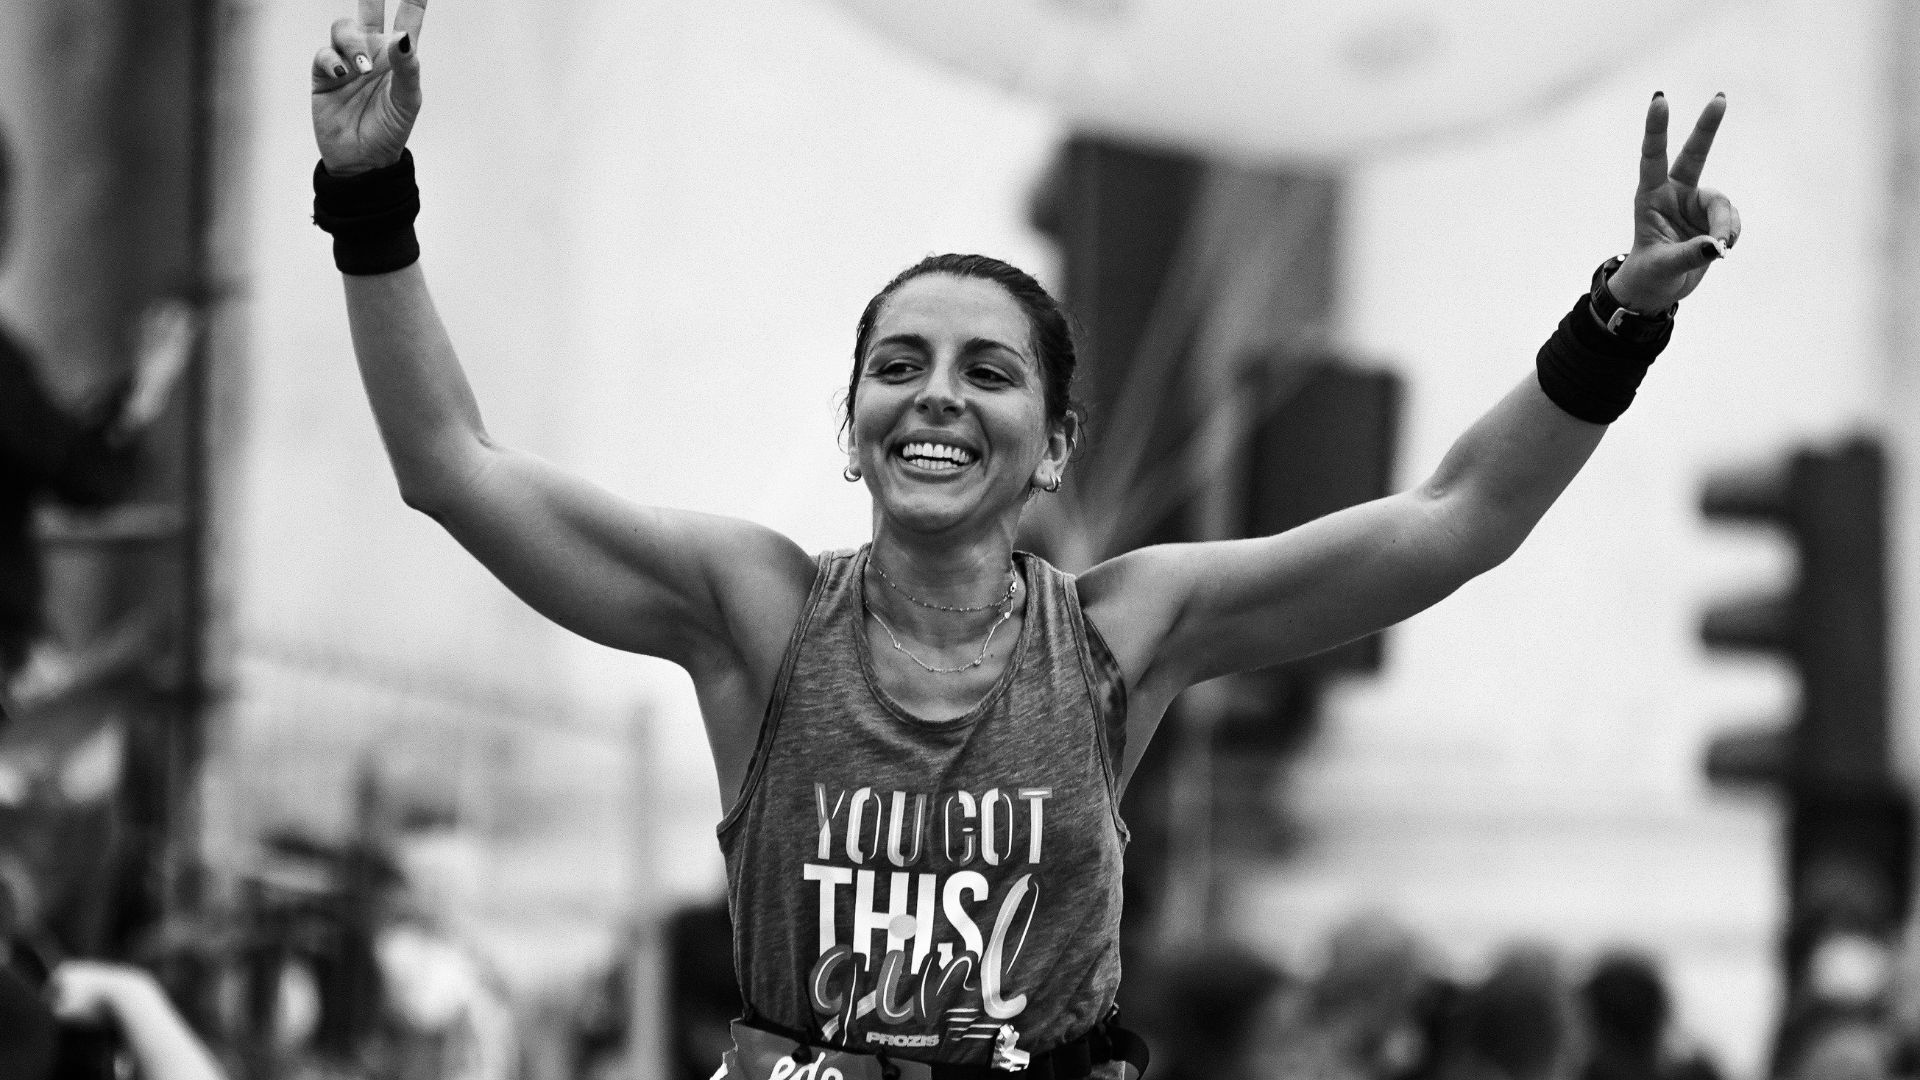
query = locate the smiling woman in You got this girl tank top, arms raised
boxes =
[311,0,1740,1080]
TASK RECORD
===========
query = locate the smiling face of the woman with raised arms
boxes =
[849,273,1069,532]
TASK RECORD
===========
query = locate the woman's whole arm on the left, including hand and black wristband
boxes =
[313,0,814,680]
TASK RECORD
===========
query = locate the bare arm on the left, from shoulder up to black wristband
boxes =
[344,263,814,664]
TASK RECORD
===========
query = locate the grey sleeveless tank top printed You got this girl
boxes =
[718,548,1127,1074]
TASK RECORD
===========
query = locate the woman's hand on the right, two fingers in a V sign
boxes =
[1609,94,1740,313]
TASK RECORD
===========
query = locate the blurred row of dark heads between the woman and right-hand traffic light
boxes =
[1129,917,1722,1080]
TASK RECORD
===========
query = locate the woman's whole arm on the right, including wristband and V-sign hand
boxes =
[1081,94,1740,713]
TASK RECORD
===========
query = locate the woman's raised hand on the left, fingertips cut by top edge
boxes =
[313,0,426,177]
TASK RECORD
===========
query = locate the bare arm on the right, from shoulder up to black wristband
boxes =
[1081,368,1605,701]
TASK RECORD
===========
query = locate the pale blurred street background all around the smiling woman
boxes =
[0,0,1920,1080]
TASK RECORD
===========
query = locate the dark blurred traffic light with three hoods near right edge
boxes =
[1701,430,1914,1072]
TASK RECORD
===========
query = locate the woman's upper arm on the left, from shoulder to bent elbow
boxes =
[422,438,814,682]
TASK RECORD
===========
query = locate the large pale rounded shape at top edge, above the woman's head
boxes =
[841,0,1724,161]
